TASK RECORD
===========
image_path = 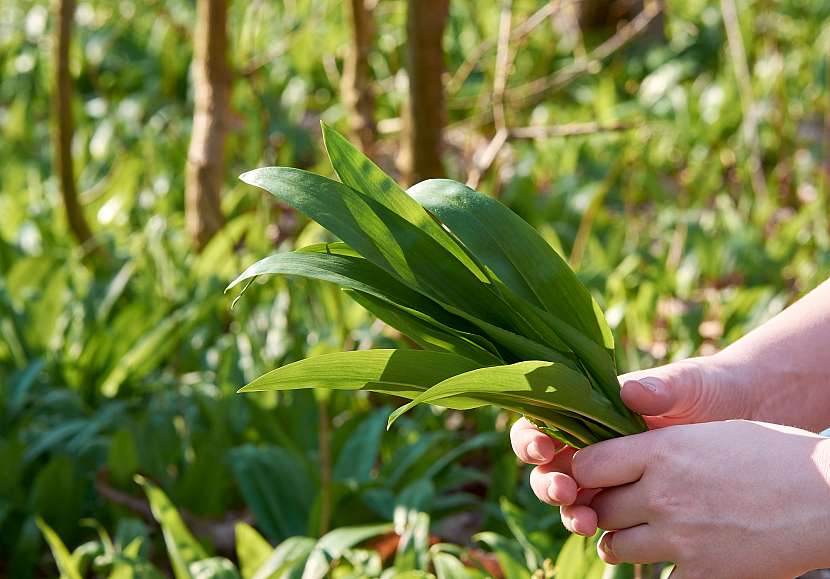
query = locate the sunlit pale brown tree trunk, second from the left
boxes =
[185,0,231,249]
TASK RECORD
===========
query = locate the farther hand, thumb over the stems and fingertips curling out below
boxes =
[510,356,756,516]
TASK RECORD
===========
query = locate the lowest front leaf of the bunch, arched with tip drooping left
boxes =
[389,361,642,434]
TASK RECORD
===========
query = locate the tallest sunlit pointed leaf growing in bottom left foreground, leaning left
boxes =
[135,475,208,579]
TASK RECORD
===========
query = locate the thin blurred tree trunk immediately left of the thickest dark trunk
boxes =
[341,0,376,155]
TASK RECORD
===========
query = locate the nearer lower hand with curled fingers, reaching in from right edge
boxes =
[576,420,830,579]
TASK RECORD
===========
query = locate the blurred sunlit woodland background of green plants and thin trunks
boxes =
[0,0,830,578]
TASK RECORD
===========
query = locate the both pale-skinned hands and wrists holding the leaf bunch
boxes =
[510,280,830,579]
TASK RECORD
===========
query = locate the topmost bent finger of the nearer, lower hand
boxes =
[571,432,658,489]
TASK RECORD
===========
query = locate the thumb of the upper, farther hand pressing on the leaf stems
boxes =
[620,360,705,422]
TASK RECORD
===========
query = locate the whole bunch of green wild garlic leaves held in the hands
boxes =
[230,125,645,448]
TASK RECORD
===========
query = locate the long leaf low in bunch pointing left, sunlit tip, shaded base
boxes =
[239,350,481,409]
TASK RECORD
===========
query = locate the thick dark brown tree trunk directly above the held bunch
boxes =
[401,0,449,184]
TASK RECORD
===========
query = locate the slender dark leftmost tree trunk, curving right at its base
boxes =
[52,0,94,255]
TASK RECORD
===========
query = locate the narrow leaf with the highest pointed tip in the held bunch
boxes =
[321,123,487,281]
